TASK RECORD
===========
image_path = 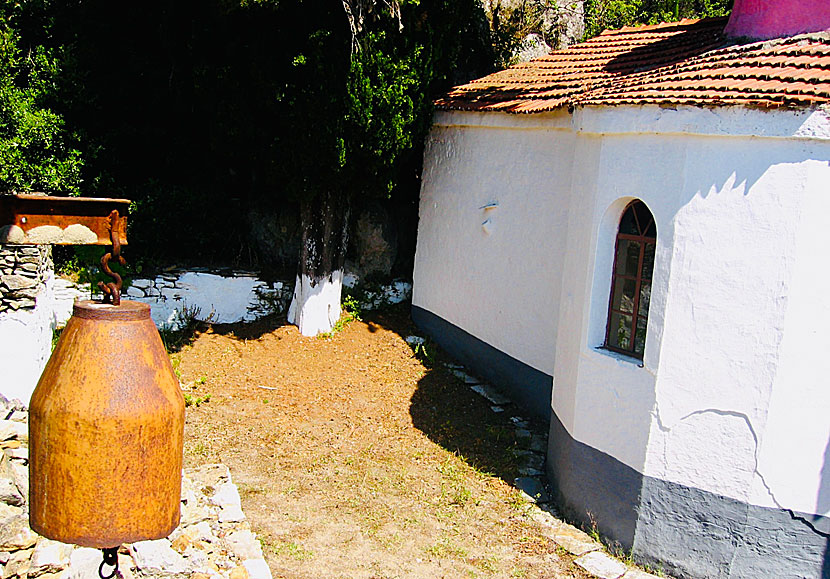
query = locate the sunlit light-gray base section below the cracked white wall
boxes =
[634,477,830,579]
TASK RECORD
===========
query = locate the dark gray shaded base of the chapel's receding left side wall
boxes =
[412,305,553,421]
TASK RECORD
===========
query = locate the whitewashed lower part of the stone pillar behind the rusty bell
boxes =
[0,274,55,406]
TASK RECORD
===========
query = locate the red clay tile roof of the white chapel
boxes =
[436,18,830,113]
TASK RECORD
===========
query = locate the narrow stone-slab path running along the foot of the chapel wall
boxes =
[446,362,668,579]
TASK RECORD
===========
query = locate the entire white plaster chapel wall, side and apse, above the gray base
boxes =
[413,107,830,513]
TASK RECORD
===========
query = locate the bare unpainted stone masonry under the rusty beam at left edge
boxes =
[0,245,52,313]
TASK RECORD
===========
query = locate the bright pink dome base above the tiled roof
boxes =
[725,0,830,40]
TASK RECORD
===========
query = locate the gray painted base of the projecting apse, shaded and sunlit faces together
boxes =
[547,413,830,579]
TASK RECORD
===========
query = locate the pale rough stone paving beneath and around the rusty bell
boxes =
[0,396,272,579]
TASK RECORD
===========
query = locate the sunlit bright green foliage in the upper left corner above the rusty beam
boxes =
[0,1,83,194]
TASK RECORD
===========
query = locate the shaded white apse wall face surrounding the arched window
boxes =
[554,134,688,472]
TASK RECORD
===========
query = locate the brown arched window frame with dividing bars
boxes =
[603,199,657,360]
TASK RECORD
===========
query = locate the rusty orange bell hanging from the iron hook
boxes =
[29,301,184,549]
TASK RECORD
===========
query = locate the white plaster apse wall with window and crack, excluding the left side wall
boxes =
[553,107,830,513]
